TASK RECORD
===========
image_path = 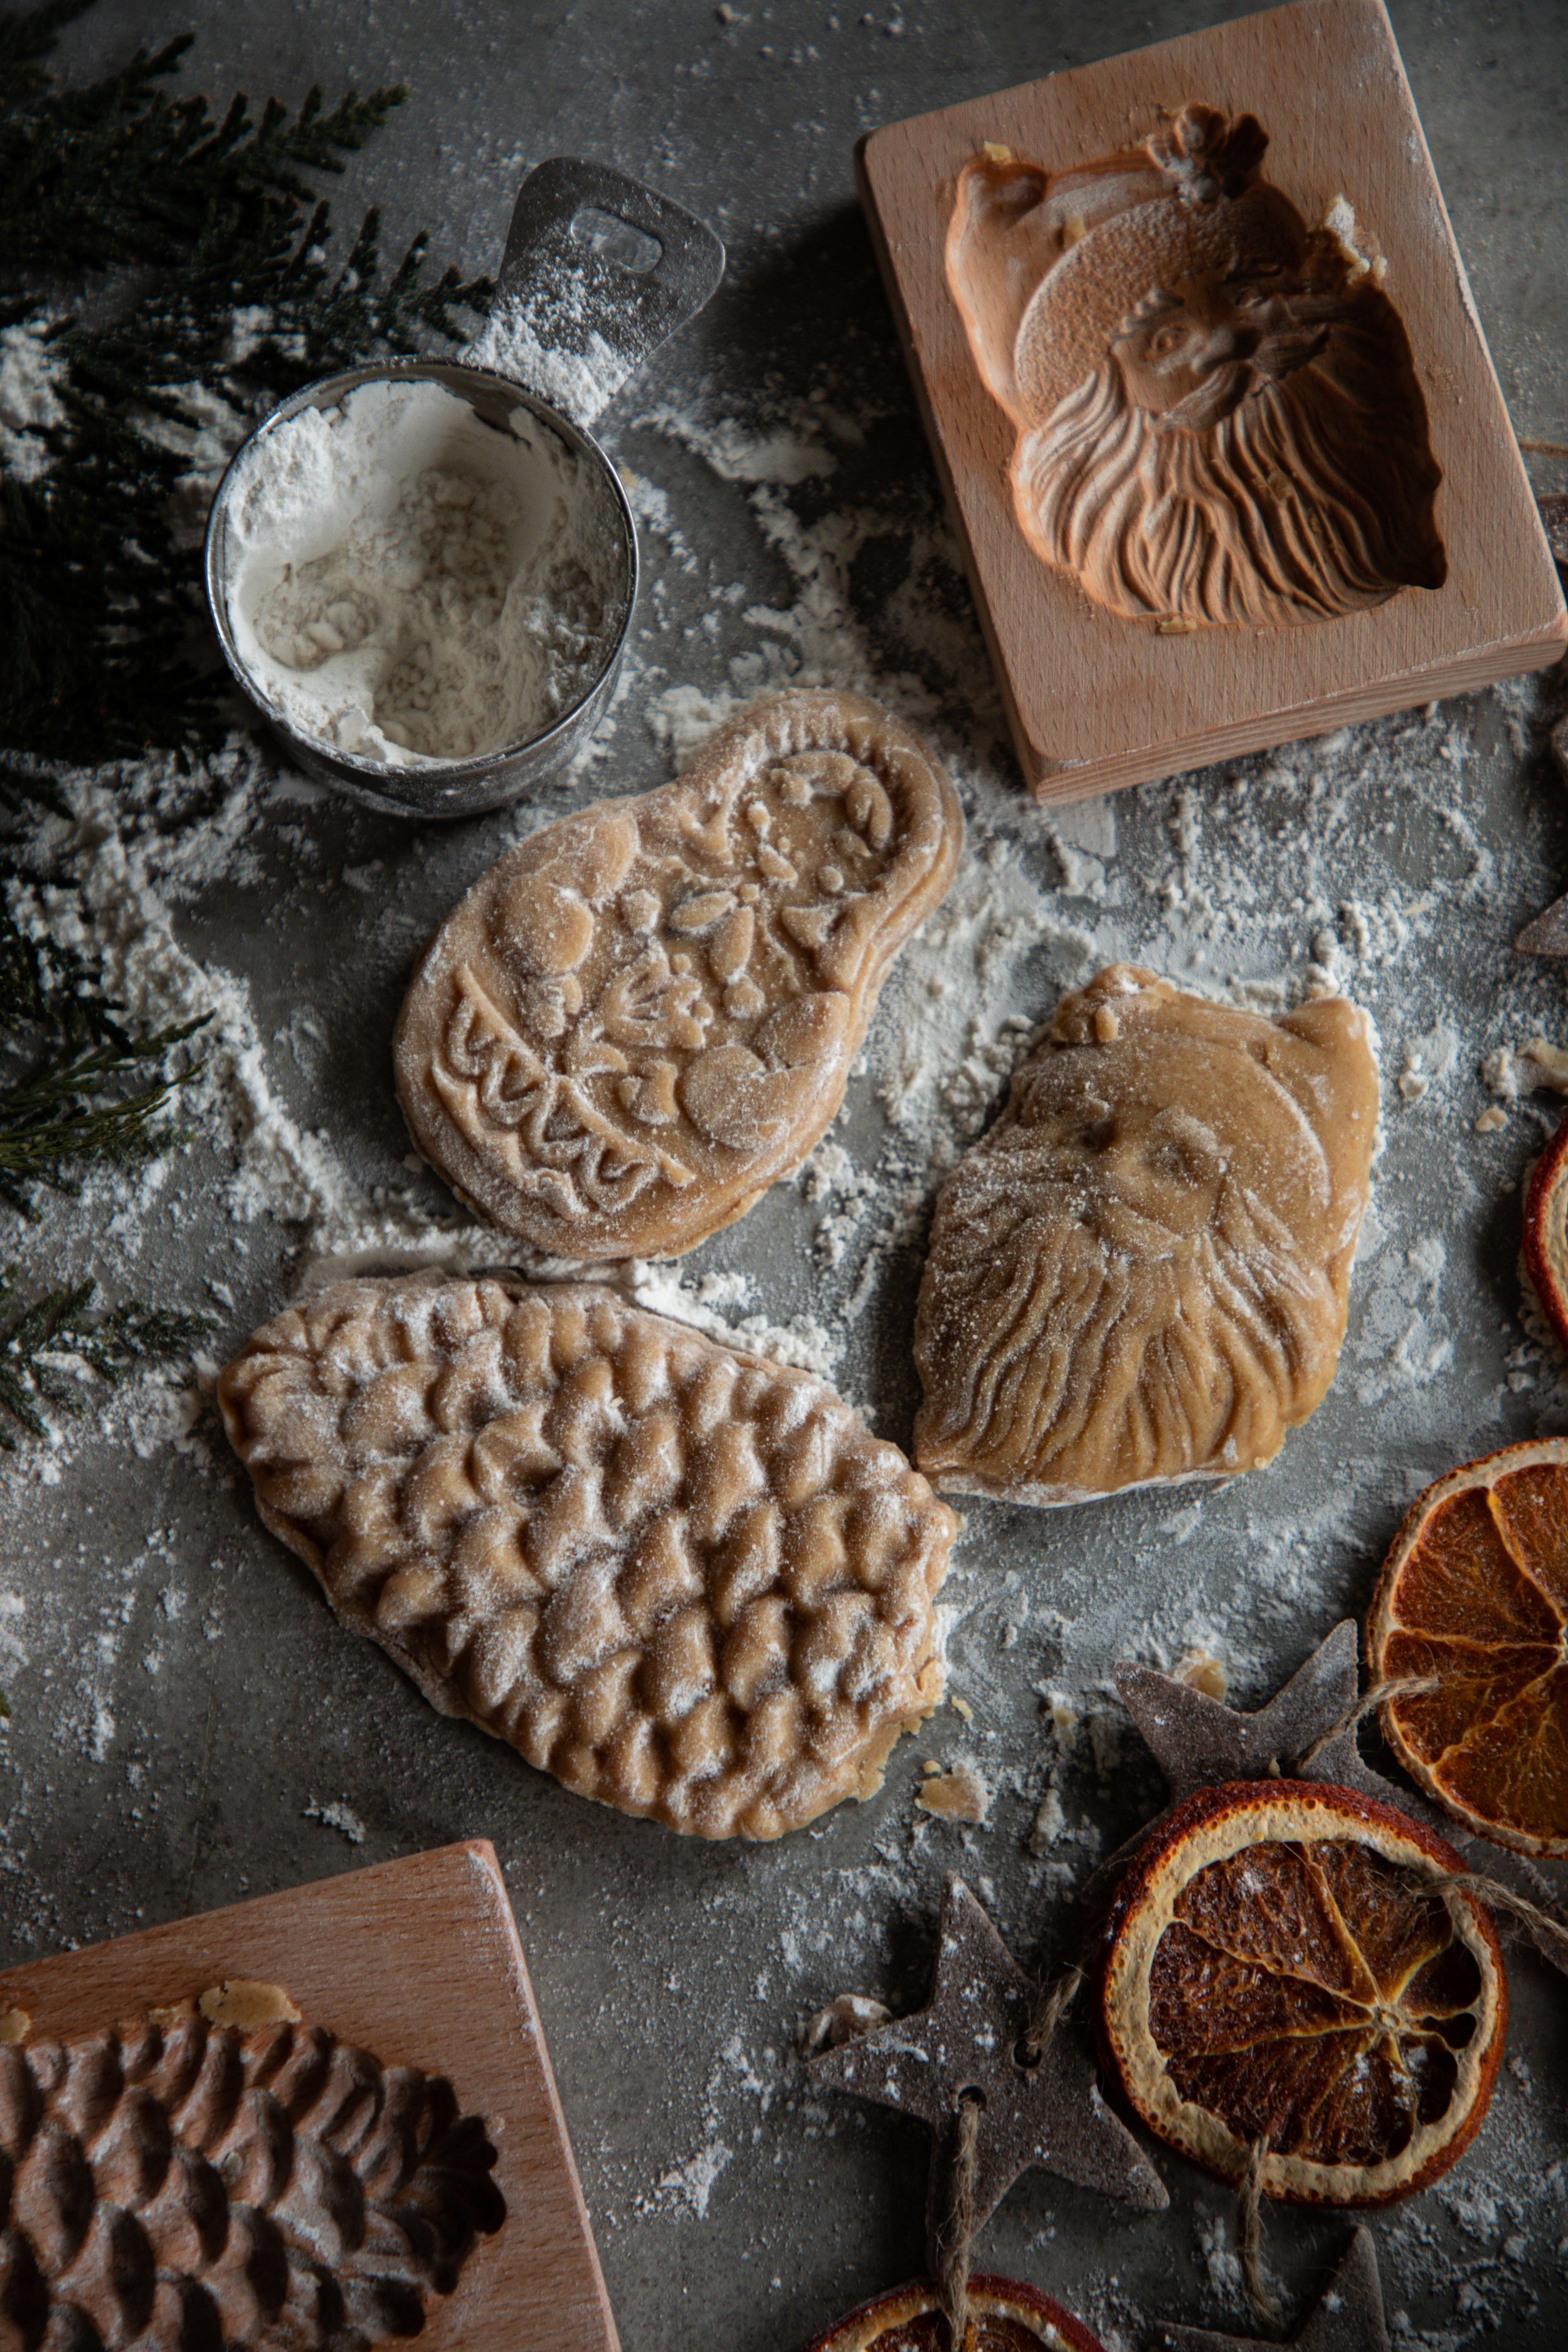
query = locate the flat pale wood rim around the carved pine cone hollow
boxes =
[0,1840,621,2352]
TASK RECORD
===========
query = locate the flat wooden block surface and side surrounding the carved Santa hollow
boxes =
[858,0,1568,800]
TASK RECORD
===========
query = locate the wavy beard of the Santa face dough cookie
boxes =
[919,1113,1338,1501]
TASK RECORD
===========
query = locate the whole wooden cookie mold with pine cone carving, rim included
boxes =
[0,1841,618,2352]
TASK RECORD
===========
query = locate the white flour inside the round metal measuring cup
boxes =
[226,381,623,767]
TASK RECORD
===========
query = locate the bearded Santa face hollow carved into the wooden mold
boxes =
[947,106,1448,628]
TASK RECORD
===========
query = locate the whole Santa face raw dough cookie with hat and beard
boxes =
[914,965,1377,1503]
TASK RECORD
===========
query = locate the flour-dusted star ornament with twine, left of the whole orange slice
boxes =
[807,1877,1171,2260]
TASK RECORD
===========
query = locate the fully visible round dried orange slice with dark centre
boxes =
[1100,1781,1507,2206]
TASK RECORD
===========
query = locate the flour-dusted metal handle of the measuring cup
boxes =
[463,156,724,426]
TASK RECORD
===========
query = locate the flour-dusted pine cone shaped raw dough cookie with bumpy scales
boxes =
[219,1275,956,1837]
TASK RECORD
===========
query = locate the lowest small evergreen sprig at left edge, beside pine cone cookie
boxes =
[0,1266,211,1454]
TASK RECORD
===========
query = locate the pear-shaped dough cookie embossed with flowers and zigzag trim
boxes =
[395,694,964,1261]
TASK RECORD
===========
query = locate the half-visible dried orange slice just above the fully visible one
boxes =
[1366,1437,1568,1853]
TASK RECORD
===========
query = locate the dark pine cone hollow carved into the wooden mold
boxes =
[0,2004,506,2352]
